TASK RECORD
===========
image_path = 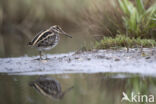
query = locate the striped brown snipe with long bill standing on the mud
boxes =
[28,25,72,60]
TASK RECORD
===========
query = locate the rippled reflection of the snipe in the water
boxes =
[29,76,73,99]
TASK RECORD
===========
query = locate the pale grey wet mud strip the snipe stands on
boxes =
[0,48,156,76]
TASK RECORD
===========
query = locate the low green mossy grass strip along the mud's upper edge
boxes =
[95,35,156,49]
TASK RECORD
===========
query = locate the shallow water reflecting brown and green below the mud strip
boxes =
[0,73,156,104]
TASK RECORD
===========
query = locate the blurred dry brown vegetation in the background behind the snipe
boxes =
[0,0,154,37]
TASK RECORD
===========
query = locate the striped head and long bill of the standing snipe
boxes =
[50,25,72,38]
